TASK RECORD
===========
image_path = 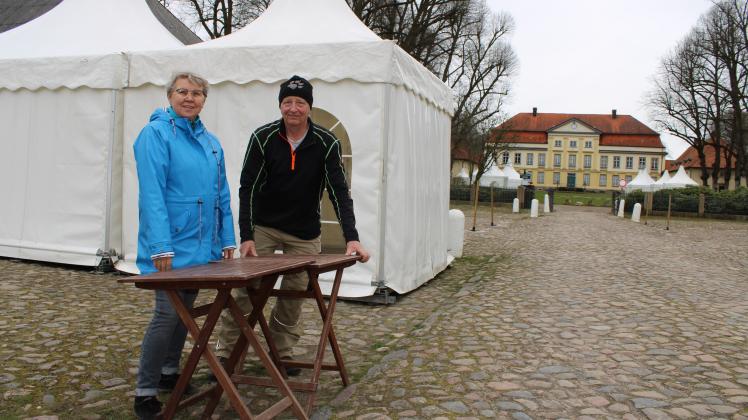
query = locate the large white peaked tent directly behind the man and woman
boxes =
[118,0,454,297]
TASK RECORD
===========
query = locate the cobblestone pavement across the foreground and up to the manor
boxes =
[0,206,748,420]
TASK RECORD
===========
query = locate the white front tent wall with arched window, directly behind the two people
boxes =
[122,81,382,297]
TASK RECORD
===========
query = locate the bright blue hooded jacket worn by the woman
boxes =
[133,109,236,274]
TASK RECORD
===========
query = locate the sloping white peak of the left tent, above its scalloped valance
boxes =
[0,0,196,58]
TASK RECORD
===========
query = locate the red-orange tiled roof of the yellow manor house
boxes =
[496,112,664,148]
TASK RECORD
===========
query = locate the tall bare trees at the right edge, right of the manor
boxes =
[648,0,748,189]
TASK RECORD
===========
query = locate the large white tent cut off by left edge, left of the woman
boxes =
[0,0,187,266]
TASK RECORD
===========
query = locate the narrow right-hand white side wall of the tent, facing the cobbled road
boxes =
[385,88,450,293]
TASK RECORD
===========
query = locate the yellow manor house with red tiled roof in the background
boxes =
[493,108,667,190]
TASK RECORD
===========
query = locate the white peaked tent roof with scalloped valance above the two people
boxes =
[129,0,455,115]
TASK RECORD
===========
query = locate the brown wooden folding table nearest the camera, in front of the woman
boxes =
[120,255,317,419]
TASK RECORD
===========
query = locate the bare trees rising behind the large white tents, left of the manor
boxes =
[161,0,518,178]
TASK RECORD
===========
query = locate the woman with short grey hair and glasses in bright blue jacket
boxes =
[133,73,236,419]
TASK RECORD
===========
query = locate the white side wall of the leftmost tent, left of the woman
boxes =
[0,88,112,264]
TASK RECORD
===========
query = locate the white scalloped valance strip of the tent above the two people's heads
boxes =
[128,41,454,114]
